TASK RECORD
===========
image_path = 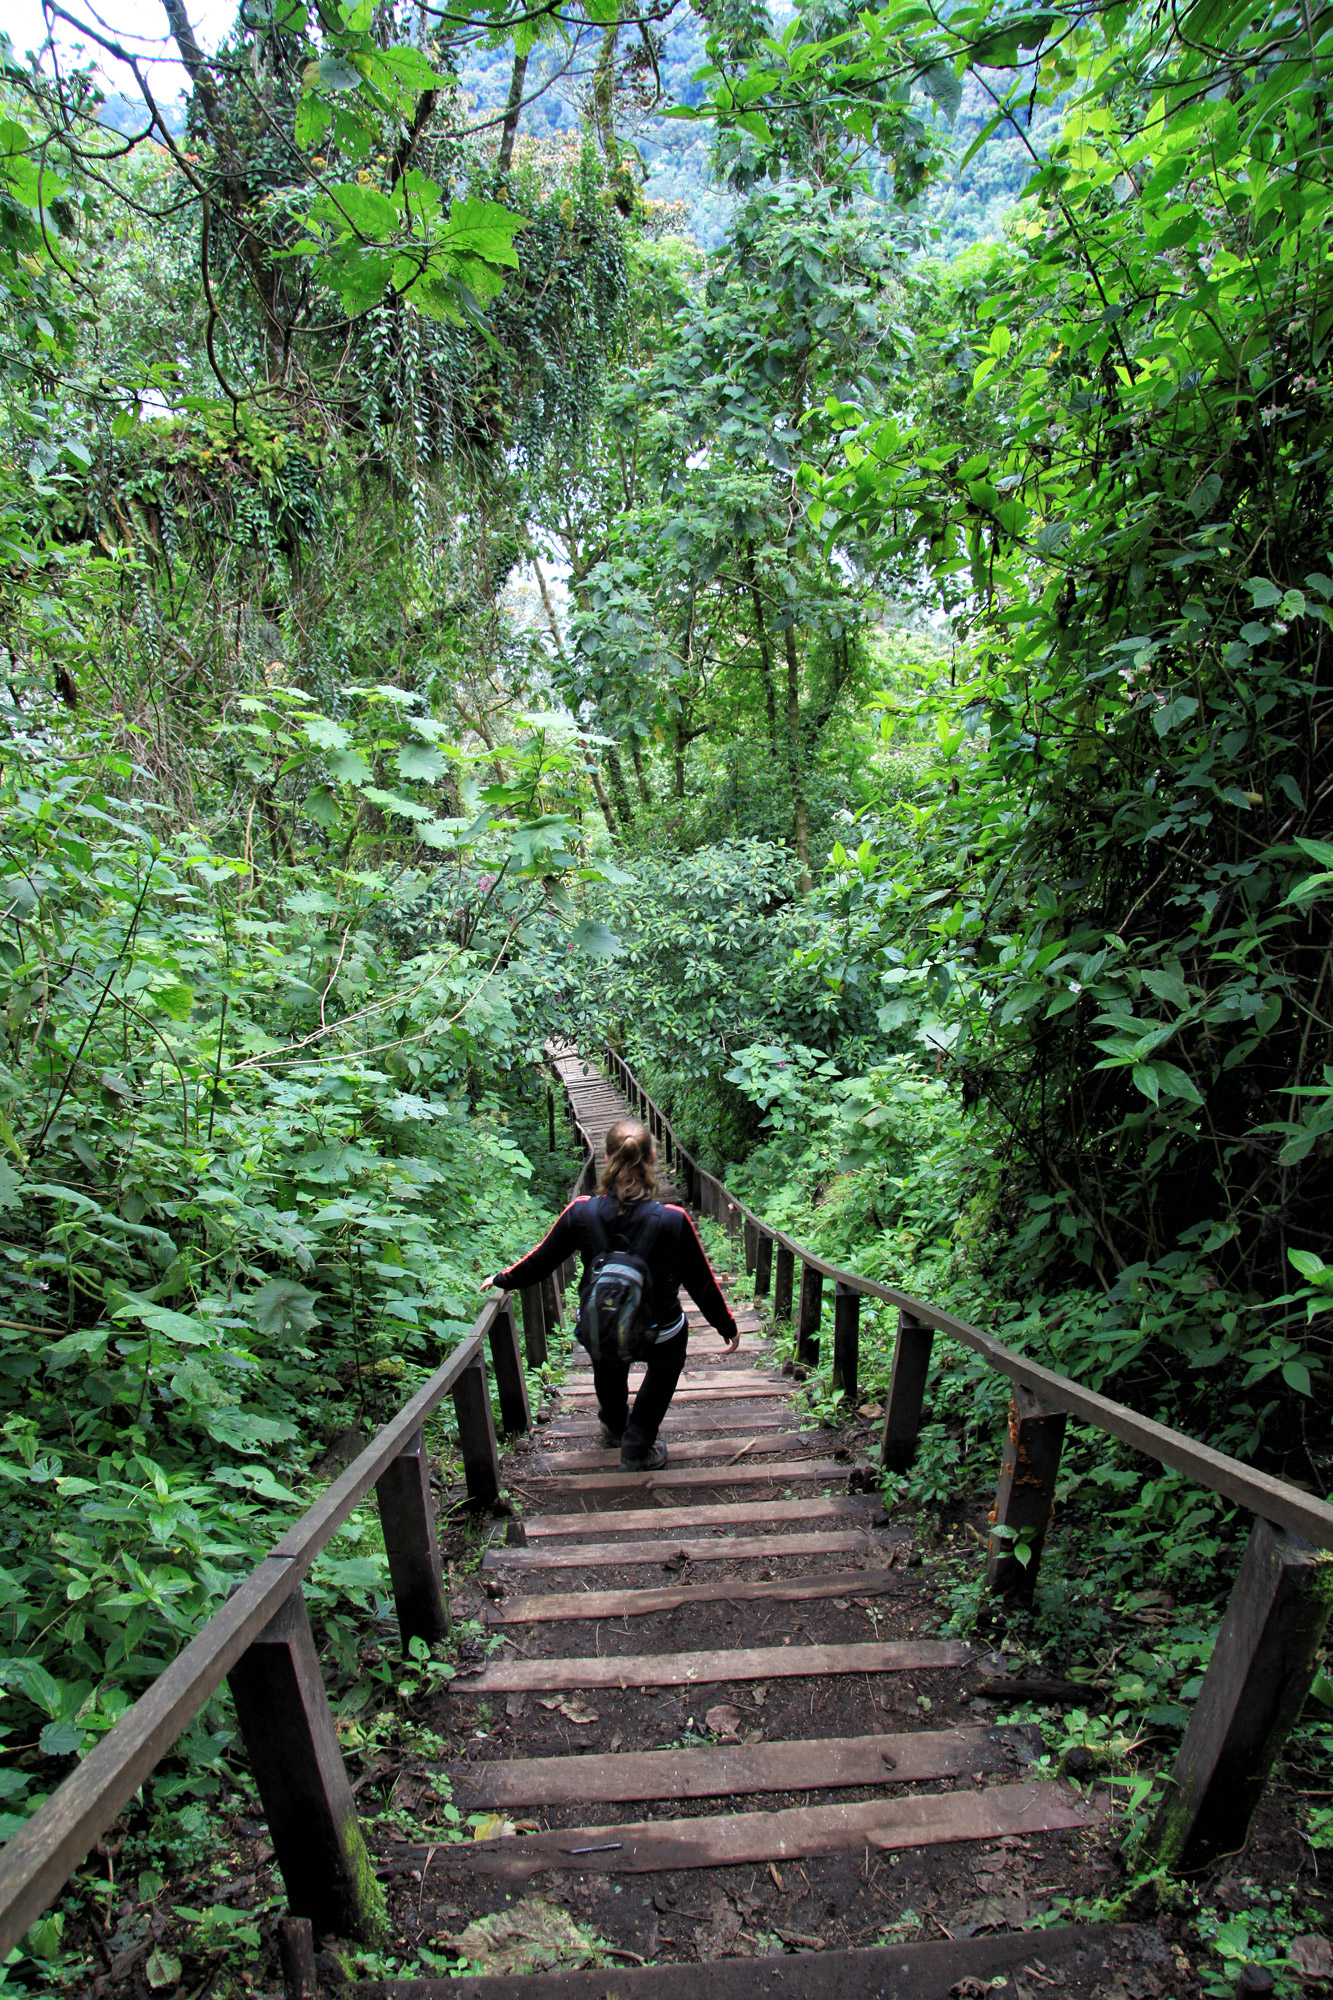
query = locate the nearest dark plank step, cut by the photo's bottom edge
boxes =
[348,1924,1119,2000]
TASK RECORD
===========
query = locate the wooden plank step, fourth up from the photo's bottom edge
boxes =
[450,1638,960,1694]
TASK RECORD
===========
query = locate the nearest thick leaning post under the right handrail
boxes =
[1149,1520,1333,1868]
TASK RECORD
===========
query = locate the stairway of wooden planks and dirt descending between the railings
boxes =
[374,1054,1144,2000]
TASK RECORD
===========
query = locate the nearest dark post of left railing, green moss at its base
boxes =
[226,1584,388,1944]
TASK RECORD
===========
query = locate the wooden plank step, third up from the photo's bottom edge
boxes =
[444,1730,1016,1812]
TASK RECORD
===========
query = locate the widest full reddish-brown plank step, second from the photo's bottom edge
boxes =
[392,1784,1101,1882]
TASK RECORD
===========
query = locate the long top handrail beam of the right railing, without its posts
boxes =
[608,1050,1333,1550]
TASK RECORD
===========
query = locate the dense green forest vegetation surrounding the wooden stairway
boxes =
[0,0,1333,1990]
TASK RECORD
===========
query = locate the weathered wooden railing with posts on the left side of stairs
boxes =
[0,1072,592,1960]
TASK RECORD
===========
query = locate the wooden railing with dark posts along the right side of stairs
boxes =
[606,1048,1333,1868]
